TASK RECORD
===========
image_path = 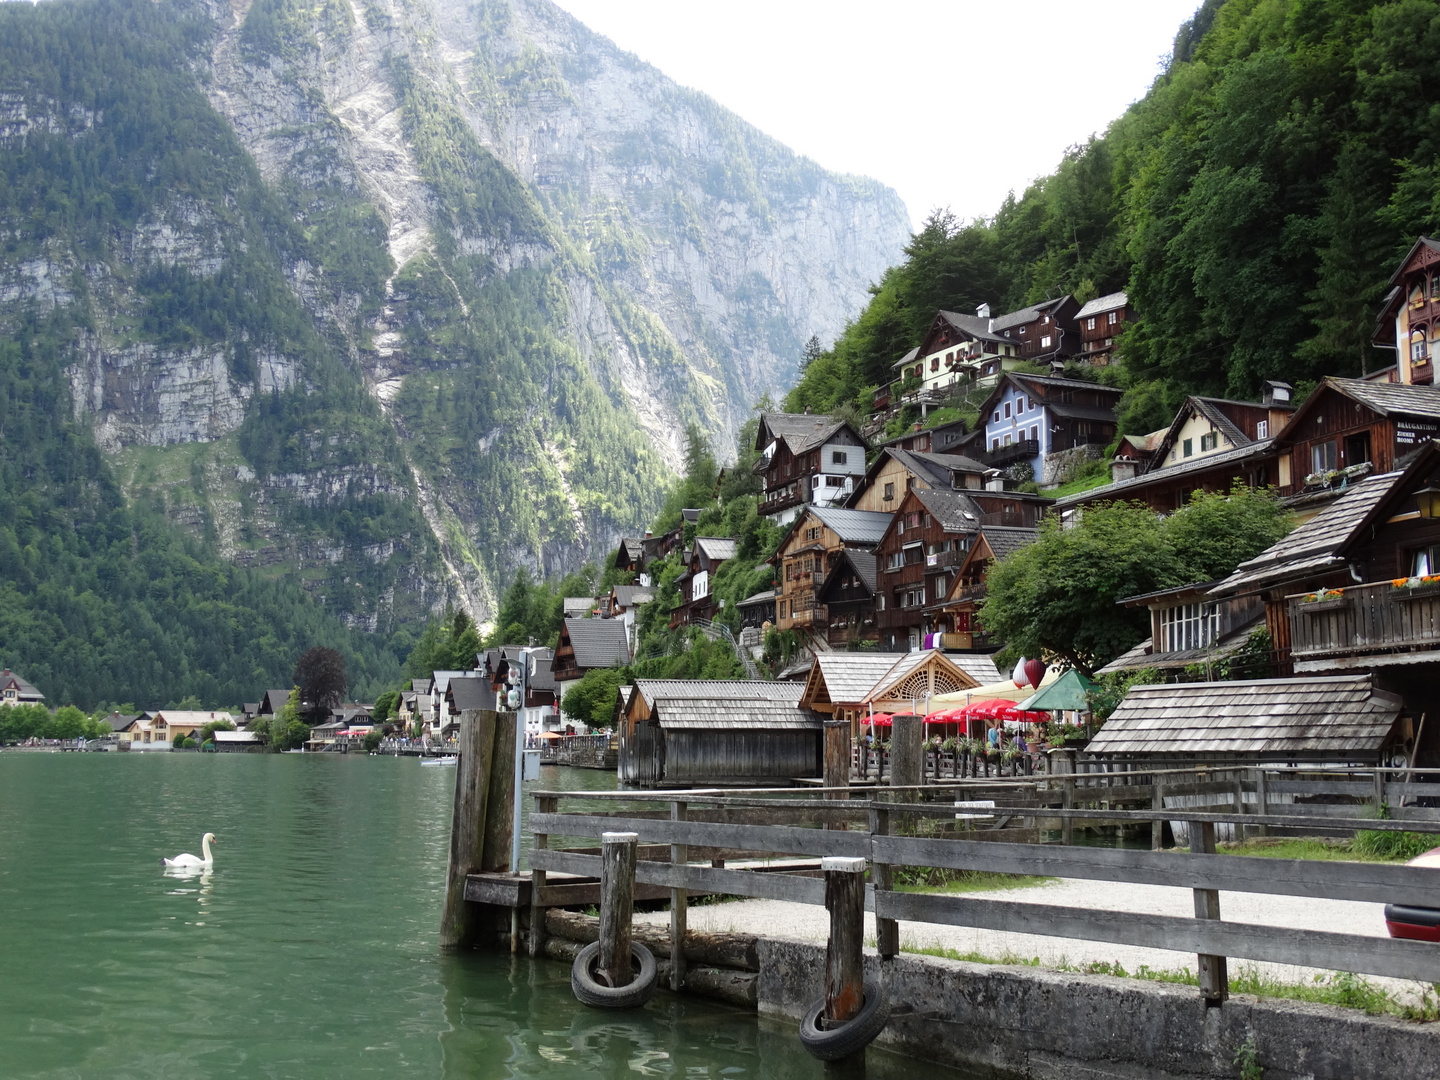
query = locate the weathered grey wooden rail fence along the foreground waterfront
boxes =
[530,769,1440,1001]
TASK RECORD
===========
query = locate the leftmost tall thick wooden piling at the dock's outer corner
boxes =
[441,708,495,949]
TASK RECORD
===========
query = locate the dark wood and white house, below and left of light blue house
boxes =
[755,412,868,524]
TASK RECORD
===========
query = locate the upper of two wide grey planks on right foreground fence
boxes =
[871,835,1440,907]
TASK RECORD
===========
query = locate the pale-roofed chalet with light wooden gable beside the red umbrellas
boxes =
[799,649,999,734]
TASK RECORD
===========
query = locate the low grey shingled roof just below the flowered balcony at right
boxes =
[1086,672,1404,760]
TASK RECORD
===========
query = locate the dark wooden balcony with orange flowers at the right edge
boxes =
[1286,580,1440,672]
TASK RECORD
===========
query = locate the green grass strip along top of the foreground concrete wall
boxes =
[900,942,1440,1022]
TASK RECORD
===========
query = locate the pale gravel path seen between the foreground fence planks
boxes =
[635,880,1423,1001]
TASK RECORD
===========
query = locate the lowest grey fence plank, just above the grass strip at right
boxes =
[876,893,1440,982]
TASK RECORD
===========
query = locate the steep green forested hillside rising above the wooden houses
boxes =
[789,0,1440,431]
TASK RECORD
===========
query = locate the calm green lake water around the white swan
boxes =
[0,753,953,1080]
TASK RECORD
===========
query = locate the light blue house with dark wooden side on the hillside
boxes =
[975,372,1122,484]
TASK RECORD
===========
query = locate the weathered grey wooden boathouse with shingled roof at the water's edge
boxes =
[616,678,824,788]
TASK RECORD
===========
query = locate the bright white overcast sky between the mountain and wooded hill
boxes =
[556,0,1198,225]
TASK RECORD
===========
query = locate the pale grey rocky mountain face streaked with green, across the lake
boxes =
[0,0,909,629]
